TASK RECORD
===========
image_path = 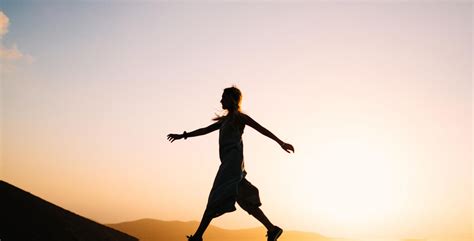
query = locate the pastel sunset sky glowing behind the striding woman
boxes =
[0,0,474,240]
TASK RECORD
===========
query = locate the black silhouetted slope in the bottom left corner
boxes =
[0,181,138,241]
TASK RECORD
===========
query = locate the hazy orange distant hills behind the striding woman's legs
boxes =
[108,219,336,241]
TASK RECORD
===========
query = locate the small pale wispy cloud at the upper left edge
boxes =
[0,11,34,73]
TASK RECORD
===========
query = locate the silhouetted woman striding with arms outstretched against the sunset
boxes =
[168,87,294,241]
